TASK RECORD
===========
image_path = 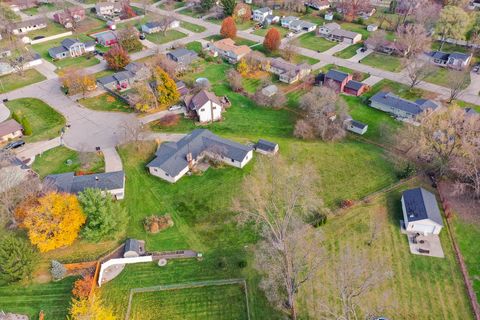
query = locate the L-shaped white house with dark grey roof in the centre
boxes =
[147,129,253,182]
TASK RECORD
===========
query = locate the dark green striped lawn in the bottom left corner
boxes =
[0,277,75,319]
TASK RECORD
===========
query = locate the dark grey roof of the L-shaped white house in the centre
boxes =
[147,129,252,177]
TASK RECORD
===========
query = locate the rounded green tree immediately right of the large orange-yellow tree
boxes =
[78,189,128,242]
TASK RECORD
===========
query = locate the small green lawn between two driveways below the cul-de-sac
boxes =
[32,146,105,178]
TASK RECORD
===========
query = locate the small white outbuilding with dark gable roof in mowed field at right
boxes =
[401,188,443,235]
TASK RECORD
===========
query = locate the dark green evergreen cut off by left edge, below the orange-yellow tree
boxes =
[0,234,38,283]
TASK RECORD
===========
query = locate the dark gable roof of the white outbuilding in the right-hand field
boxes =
[403,188,443,226]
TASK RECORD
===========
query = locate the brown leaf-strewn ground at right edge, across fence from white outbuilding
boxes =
[439,181,480,226]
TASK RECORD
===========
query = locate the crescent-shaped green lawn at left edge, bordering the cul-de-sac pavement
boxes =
[5,98,65,142]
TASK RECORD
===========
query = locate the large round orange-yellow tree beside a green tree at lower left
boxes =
[23,192,86,252]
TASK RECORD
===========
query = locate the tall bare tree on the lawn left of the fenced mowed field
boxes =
[233,157,323,319]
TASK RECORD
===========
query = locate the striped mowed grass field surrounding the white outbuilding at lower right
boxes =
[299,181,473,320]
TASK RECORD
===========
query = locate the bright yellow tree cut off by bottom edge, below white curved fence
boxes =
[70,294,117,320]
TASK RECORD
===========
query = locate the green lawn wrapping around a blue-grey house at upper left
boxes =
[32,34,100,71]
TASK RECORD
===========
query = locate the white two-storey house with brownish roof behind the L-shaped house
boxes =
[183,90,223,123]
